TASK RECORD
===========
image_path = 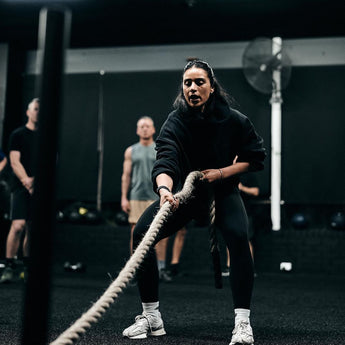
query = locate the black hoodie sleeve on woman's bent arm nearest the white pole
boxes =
[237,117,266,171]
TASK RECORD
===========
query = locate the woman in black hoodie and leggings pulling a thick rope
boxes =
[123,60,265,345]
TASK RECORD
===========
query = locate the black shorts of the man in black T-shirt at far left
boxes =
[10,188,32,220]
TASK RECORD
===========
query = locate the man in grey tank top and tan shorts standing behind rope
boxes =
[121,116,186,282]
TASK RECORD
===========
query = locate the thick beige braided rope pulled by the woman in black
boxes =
[50,171,202,345]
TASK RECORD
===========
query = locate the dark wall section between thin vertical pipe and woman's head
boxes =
[103,72,179,201]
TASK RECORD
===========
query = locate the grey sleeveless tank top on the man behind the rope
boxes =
[129,143,158,200]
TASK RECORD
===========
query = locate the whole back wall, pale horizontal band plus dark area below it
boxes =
[19,37,345,204]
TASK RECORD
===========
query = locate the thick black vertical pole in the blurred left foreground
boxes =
[22,7,71,345]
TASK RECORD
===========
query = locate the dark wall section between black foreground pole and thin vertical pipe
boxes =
[58,74,99,200]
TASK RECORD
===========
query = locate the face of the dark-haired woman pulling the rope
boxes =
[183,67,214,111]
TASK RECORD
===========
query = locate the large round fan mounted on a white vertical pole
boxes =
[242,37,291,230]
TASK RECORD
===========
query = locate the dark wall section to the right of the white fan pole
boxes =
[282,66,345,203]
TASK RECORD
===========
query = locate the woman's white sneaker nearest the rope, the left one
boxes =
[122,312,166,339]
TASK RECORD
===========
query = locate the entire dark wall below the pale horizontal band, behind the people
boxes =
[20,66,345,203]
